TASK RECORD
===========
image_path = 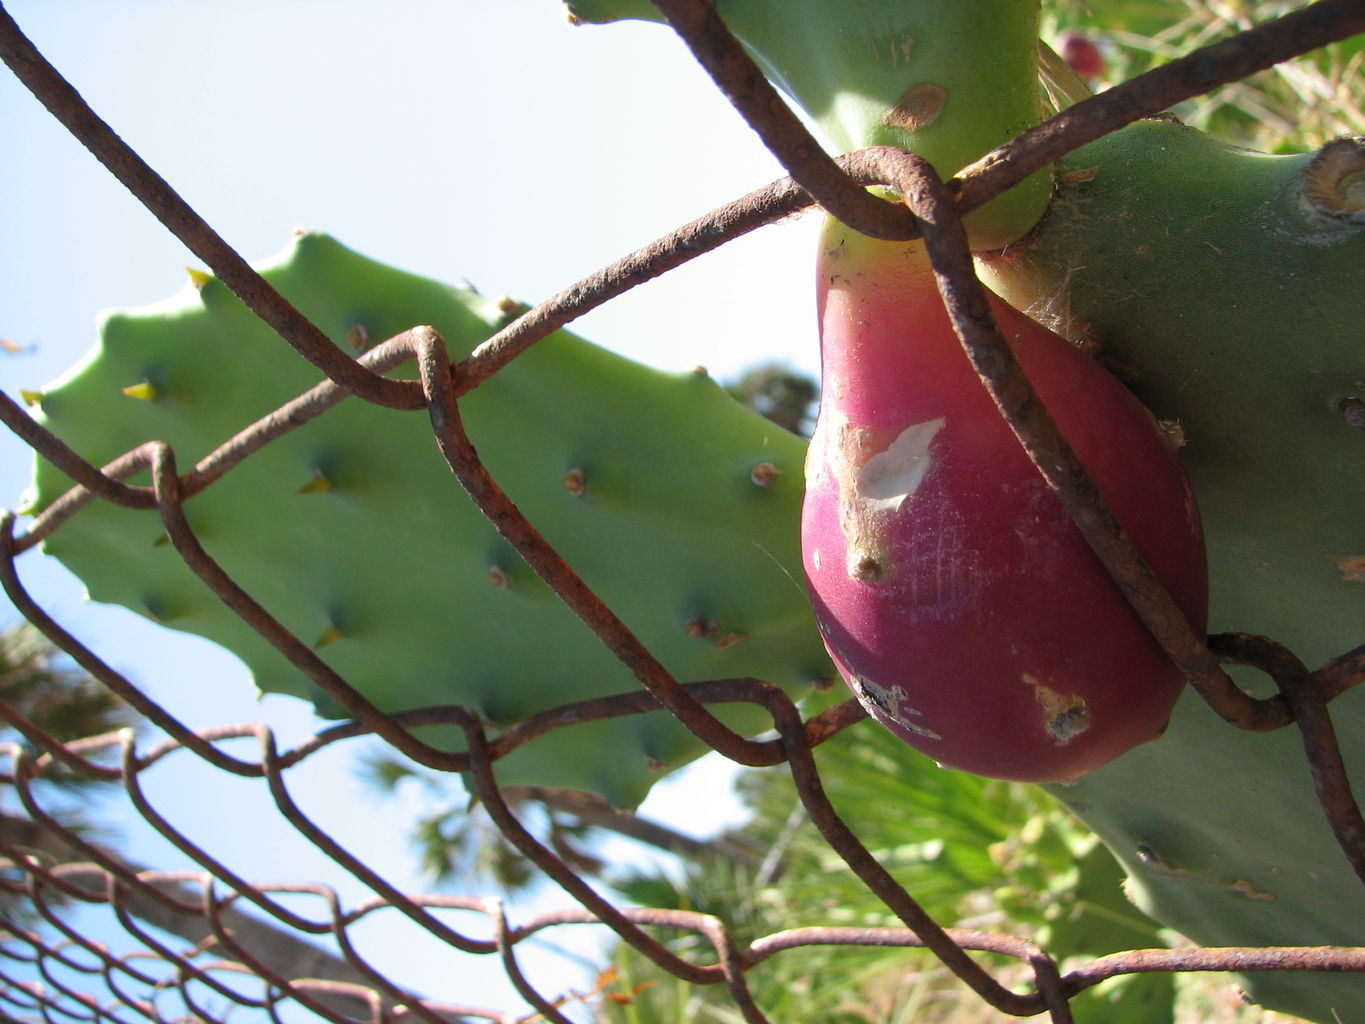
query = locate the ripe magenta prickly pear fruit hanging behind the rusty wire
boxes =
[801,221,1207,781]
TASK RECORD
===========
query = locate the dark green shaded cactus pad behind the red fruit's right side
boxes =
[986,122,1365,1021]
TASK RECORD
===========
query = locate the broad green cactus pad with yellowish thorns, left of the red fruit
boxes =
[31,233,831,807]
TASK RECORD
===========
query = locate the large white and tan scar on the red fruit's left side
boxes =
[830,416,946,583]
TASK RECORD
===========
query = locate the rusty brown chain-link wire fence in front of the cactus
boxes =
[0,0,1365,1021]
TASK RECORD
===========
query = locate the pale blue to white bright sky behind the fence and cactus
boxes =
[0,0,818,1009]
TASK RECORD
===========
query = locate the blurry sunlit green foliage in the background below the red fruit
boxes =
[603,722,1173,1024]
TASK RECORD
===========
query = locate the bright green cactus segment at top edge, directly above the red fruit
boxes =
[564,0,1051,248]
